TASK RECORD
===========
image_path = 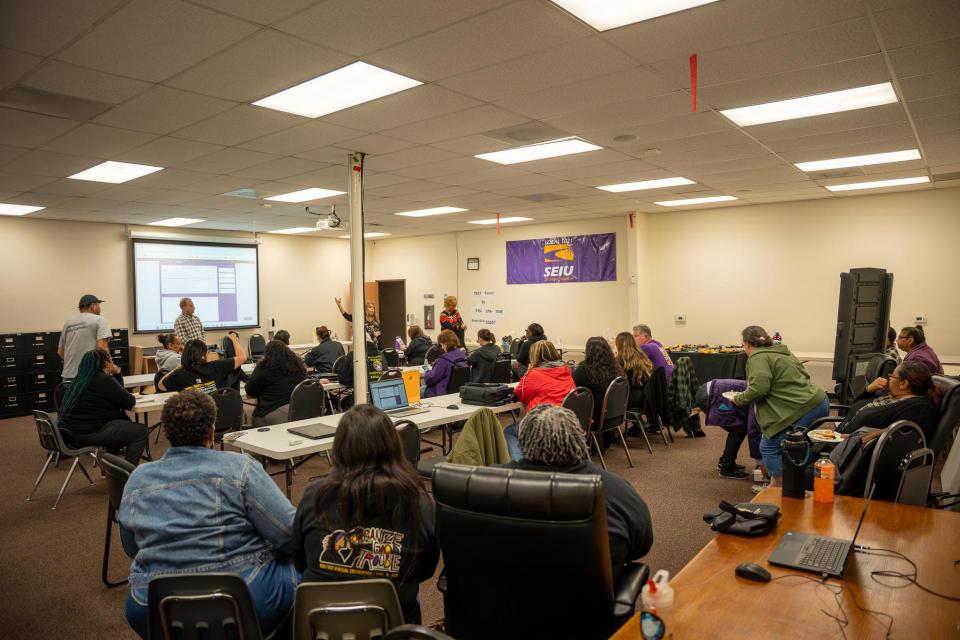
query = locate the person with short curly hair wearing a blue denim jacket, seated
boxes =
[119,391,300,638]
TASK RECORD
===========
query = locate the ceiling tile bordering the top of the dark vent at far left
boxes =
[23,59,150,104]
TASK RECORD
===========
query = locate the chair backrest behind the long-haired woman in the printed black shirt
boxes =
[293,578,403,640]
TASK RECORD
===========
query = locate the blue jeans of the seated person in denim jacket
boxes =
[124,560,300,638]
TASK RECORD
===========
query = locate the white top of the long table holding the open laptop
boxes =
[226,393,523,460]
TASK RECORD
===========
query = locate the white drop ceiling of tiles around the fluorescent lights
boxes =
[0,0,960,235]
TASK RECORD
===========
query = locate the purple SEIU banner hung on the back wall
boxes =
[507,233,617,284]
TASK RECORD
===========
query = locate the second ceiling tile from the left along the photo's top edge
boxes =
[57,0,257,82]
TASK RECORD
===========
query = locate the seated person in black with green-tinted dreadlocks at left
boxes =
[57,349,149,464]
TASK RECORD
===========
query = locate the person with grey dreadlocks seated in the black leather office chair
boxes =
[498,404,653,582]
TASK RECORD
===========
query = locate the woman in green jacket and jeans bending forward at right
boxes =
[733,326,830,487]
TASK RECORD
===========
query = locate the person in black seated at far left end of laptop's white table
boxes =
[246,340,307,427]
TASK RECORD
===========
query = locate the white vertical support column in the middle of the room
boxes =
[347,152,369,404]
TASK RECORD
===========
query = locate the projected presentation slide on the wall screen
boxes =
[133,240,260,331]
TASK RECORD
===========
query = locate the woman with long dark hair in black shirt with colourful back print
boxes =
[291,404,440,624]
